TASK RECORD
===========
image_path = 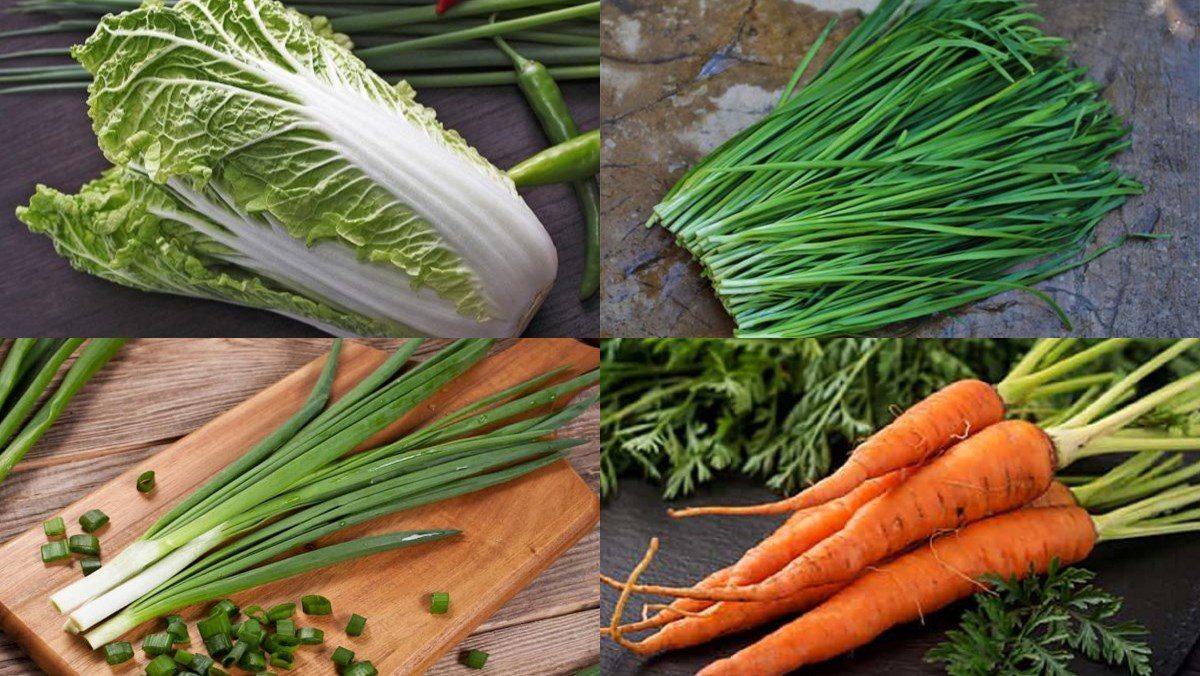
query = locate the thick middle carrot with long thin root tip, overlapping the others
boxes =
[604,420,1055,602]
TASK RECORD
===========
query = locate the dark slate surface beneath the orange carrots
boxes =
[600,478,1200,676]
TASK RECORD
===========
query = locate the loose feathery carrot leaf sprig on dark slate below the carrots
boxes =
[926,561,1153,676]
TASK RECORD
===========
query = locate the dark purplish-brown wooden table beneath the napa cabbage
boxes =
[0,7,600,337]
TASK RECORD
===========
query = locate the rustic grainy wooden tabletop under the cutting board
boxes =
[0,339,600,676]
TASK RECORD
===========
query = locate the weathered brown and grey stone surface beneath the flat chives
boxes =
[600,0,1200,336]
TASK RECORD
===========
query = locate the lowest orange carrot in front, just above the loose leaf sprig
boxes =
[700,507,1097,676]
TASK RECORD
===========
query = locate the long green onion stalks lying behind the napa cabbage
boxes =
[0,0,600,94]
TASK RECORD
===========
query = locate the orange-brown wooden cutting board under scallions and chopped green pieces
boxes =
[0,339,600,675]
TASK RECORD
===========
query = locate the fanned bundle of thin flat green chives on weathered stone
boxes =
[648,0,1141,336]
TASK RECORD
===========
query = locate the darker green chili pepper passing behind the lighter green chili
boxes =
[492,29,600,300]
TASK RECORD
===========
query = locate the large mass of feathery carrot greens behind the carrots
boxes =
[600,339,1026,498]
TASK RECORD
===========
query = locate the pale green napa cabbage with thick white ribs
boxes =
[18,0,557,336]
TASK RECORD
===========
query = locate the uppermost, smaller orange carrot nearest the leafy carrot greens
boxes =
[671,379,1004,516]
